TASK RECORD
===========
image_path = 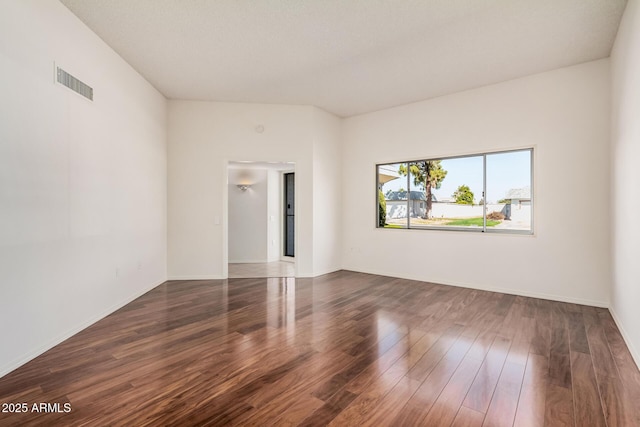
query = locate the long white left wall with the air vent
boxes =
[0,0,166,376]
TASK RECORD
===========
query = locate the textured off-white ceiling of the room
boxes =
[61,0,626,117]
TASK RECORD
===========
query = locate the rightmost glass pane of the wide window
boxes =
[487,150,532,231]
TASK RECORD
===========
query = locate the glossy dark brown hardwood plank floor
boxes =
[0,271,640,427]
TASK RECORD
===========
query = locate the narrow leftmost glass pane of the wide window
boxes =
[378,163,408,228]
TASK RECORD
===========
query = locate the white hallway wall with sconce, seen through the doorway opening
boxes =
[227,169,269,263]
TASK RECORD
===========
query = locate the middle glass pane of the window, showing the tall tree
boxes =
[404,156,482,229]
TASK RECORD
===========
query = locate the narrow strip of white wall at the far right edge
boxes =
[610,0,640,366]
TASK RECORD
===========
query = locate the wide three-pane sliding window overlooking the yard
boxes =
[376,149,533,234]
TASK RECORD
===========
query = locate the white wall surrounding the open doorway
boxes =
[168,101,314,278]
